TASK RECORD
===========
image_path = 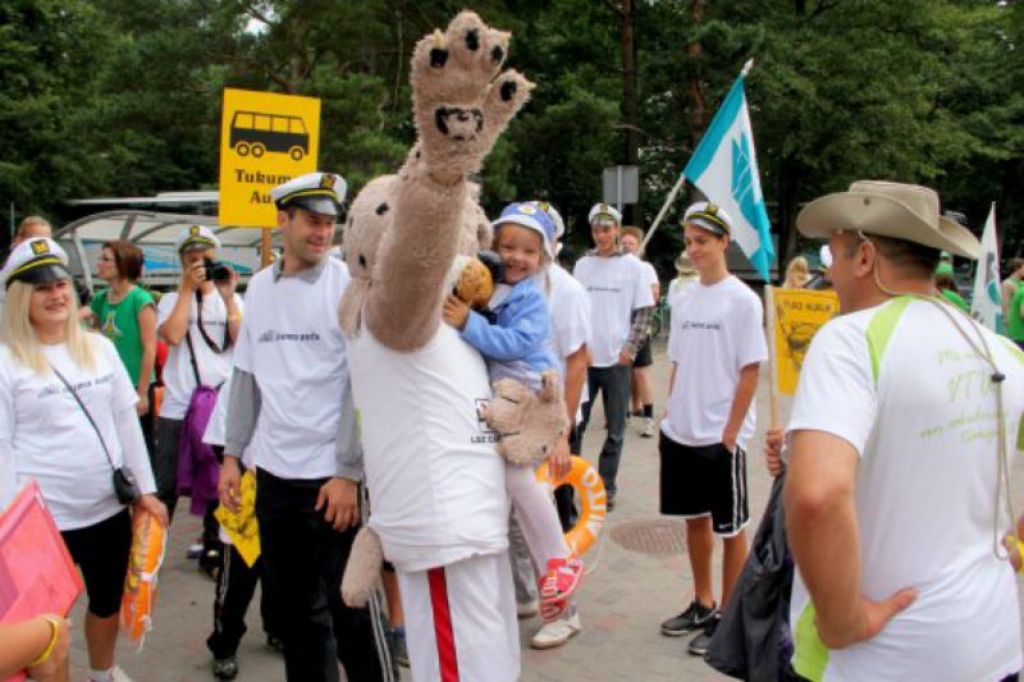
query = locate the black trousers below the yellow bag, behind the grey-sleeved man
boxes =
[206,545,285,658]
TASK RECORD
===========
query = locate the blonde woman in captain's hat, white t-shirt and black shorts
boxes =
[0,239,167,682]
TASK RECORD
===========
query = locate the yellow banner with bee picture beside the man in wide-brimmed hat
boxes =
[768,287,839,395]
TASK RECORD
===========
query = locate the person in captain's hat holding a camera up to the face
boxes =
[153,225,242,540]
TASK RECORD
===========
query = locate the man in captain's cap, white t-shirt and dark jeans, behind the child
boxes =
[572,204,654,510]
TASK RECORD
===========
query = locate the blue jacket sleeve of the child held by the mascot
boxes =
[461,292,551,363]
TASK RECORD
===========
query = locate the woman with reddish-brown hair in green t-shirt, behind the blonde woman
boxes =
[91,241,157,430]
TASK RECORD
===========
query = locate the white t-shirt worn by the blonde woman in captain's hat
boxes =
[0,334,153,530]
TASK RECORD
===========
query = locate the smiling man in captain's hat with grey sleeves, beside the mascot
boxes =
[219,173,384,682]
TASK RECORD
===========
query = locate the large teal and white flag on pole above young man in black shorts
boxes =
[683,62,775,282]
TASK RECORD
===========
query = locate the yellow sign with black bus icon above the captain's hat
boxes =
[218,88,321,227]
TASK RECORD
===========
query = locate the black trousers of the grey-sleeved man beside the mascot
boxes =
[256,470,383,682]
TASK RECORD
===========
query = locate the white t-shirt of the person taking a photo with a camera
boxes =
[157,291,242,419]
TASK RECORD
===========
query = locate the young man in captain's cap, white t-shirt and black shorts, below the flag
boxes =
[658,202,768,655]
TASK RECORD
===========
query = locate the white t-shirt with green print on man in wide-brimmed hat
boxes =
[788,297,1024,682]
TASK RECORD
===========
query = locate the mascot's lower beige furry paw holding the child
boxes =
[483,375,568,466]
